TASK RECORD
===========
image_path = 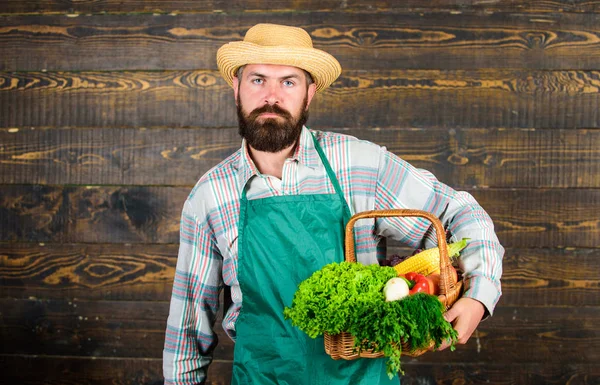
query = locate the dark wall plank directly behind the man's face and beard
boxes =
[0,69,600,129]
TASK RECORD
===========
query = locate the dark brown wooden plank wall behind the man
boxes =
[0,0,600,385]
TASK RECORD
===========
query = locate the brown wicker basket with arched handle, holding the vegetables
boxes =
[324,209,462,360]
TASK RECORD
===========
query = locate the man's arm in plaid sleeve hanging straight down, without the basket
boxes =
[163,200,223,385]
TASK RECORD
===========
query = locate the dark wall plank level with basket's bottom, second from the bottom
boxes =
[0,299,600,364]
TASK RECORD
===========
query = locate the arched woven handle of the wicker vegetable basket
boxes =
[344,209,457,305]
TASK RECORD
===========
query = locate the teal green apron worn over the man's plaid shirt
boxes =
[232,137,399,385]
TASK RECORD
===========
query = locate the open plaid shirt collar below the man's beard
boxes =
[238,126,320,193]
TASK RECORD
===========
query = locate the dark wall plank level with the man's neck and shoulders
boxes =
[0,127,600,188]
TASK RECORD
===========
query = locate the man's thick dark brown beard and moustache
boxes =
[237,95,308,152]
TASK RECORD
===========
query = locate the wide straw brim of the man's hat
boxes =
[217,41,342,92]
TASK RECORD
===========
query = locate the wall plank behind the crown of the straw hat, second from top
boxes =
[0,12,600,71]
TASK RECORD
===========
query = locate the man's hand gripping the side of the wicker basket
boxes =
[438,297,485,350]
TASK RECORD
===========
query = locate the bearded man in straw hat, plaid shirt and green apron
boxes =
[163,24,504,385]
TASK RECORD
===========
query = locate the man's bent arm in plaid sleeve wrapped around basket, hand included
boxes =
[375,148,504,343]
